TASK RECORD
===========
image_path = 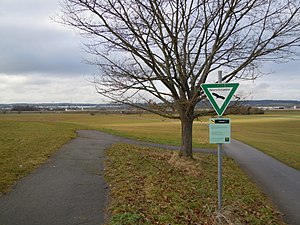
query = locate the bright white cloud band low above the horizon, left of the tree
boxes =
[0,75,103,103]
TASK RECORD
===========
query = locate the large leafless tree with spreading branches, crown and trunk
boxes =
[61,0,300,157]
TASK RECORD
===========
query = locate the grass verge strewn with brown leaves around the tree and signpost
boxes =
[105,144,284,225]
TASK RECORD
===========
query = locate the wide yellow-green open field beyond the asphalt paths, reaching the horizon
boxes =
[0,111,300,192]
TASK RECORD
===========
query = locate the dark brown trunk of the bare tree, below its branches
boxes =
[179,109,194,158]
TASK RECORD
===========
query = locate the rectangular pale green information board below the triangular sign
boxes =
[209,118,231,144]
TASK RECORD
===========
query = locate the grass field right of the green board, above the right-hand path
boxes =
[232,111,300,170]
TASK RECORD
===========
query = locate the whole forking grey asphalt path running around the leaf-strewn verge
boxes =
[0,130,300,225]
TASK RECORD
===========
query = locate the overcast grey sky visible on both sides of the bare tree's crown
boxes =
[0,0,300,103]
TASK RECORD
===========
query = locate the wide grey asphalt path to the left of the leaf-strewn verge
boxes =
[0,131,117,225]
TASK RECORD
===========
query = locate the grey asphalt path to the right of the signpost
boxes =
[223,140,300,225]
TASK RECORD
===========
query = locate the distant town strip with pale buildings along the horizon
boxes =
[0,100,300,112]
